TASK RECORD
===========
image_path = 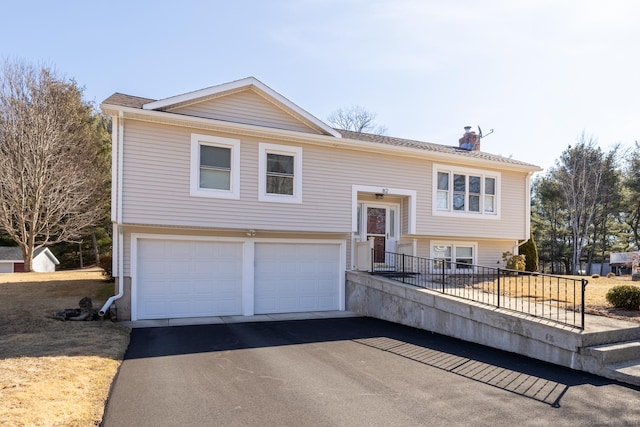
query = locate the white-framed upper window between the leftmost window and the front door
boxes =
[258,143,302,203]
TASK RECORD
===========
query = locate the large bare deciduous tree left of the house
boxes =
[0,62,108,271]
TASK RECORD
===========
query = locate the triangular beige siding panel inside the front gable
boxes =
[170,90,319,134]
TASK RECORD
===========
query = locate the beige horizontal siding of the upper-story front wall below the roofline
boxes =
[123,120,528,240]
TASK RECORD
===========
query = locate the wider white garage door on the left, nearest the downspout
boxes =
[136,239,243,319]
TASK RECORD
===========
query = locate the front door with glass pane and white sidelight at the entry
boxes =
[363,204,399,263]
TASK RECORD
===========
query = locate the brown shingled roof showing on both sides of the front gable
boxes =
[103,92,537,168]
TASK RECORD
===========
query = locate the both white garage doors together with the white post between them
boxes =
[132,235,345,320]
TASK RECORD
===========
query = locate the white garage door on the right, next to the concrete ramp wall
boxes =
[254,243,340,314]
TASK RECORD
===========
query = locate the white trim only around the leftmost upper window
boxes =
[190,133,240,199]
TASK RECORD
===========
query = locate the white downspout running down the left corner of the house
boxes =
[98,111,124,316]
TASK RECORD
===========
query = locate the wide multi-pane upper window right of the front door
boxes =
[433,165,500,217]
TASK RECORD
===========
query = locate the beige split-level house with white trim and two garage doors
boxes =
[101,78,540,320]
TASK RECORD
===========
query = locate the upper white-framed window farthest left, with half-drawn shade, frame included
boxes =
[191,134,240,199]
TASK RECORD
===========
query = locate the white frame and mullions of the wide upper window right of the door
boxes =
[431,163,502,220]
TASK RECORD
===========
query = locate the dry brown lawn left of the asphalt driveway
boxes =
[0,269,130,427]
